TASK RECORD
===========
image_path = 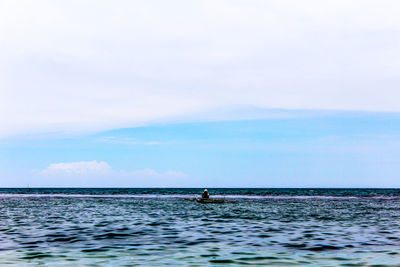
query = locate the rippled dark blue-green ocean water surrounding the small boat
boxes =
[0,188,400,266]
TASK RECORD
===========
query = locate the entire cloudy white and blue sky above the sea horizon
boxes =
[0,0,400,187]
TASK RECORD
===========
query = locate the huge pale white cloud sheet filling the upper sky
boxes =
[0,0,400,136]
